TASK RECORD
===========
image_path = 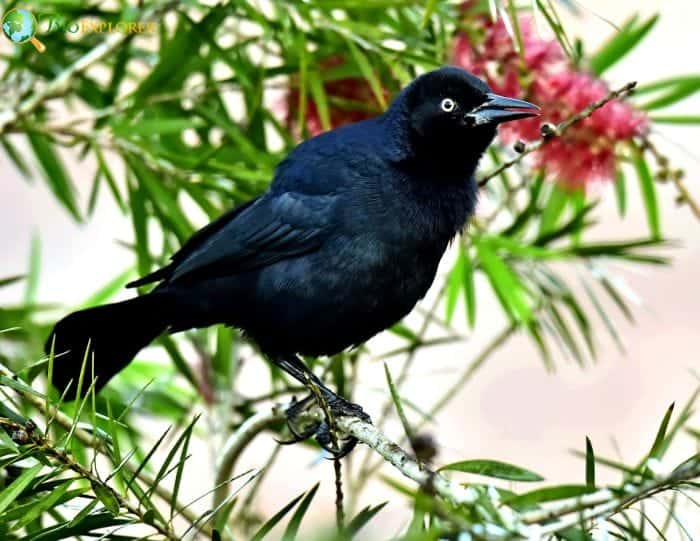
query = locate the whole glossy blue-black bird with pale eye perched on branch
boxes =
[46,67,538,454]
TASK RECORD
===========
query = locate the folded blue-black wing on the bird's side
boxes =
[167,192,335,282]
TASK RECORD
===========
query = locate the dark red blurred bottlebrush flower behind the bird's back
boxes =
[286,56,388,135]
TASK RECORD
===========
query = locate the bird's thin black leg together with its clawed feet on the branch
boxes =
[275,356,371,458]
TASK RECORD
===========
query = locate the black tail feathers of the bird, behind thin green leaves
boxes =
[44,293,168,394]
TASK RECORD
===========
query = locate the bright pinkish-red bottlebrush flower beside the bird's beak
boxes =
[452,12,647,188]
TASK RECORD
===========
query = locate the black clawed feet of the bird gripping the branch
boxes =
[282,392,372,459]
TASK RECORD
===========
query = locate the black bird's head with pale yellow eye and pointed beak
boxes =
[397,66,539,171]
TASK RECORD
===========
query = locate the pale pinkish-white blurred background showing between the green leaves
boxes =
[0,0,700,539]
